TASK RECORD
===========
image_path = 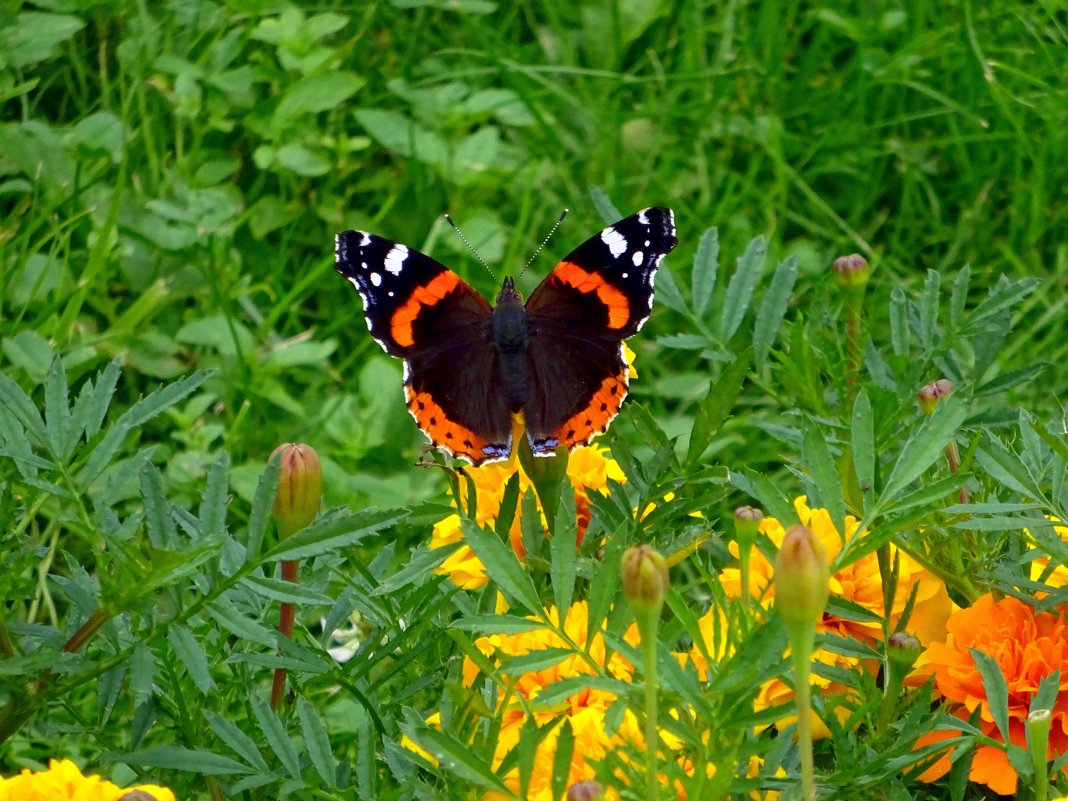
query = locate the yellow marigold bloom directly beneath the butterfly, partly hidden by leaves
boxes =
[430,445,626,590]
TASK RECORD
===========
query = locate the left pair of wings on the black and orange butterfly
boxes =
[335,231,512,465]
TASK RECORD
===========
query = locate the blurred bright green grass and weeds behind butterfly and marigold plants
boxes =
[0,0,1068,505]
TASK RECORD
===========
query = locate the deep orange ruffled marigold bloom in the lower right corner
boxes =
[917,595,1068,796]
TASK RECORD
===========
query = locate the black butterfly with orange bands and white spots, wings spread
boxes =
[334,208,677,465]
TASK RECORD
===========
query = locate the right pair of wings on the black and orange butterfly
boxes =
[524,208,677,456]
